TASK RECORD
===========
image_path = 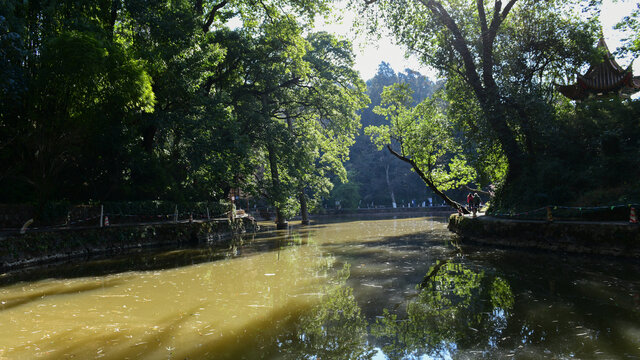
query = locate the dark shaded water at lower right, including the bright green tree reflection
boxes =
[371,240,640,359]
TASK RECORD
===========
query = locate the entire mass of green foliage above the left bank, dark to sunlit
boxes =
[0,0,365,214]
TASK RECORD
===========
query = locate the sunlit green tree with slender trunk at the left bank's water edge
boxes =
[287,32,369,224]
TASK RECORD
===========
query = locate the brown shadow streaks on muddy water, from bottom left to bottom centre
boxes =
[25,266,376,360]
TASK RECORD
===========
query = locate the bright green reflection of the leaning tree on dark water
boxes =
[371,262,514,359]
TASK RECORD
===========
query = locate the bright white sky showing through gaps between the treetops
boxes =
[315,0,640,80]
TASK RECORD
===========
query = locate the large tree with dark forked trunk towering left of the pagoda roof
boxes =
[360,0,596,183]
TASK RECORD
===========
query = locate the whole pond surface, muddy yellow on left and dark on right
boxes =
[0,216,640,359]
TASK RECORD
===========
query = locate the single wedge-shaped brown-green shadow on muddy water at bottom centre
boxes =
[148,266,375,360]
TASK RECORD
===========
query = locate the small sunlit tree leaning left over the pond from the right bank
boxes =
[365,84,474,213]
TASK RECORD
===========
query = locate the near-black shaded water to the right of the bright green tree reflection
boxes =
[470,251,640,358]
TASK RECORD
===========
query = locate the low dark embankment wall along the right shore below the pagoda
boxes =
[448,214,640,259]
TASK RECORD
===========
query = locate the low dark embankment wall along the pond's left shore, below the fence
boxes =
[0,219,254,271]
